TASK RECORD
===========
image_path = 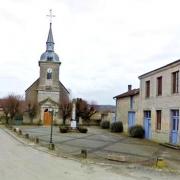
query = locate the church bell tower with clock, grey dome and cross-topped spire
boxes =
[38,11,61,103]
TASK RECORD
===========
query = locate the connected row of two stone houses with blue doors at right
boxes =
[114,60,180,145]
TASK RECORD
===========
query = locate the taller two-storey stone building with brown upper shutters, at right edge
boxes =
[138,60,180,144]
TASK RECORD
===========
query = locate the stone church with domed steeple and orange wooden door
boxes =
[25,22,69,125]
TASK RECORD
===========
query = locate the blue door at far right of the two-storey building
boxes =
[170,110,179,144]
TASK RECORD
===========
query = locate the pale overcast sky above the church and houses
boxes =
[0,0,180,104]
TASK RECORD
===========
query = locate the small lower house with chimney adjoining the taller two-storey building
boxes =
[114,85,139,132]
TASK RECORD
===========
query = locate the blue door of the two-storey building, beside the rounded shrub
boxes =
[144,111,151,139]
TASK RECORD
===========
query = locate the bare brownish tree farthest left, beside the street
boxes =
[2,94,23,124]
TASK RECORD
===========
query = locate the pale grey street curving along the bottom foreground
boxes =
[0,128,180,180]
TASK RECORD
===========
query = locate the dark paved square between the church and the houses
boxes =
[19,126,180,165]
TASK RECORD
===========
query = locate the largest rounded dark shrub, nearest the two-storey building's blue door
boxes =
[129,125,145,138]
